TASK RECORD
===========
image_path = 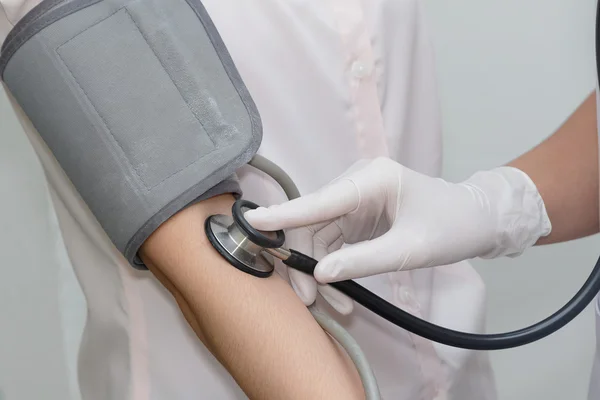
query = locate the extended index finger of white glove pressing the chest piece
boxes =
[244,179,359,231]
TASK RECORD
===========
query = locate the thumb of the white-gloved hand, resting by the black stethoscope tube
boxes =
[314,232,425,283]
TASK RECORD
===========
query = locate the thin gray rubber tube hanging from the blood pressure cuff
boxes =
[248,154,381,400]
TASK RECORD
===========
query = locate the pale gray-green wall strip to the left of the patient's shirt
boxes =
[0,83,85,400]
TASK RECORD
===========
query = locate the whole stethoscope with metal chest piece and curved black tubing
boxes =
[205,4,600,350]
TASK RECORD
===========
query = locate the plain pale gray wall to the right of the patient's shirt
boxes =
[425,0,600,400]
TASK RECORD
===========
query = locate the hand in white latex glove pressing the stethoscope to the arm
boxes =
[245,158,551,306]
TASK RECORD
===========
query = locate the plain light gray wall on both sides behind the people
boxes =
[0,0,600,400]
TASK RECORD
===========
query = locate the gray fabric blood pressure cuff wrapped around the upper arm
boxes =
[0,0,262,269]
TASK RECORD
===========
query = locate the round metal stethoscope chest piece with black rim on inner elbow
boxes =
[204,200,285,278]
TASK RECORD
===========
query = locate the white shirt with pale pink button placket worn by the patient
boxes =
[0,0,496,400]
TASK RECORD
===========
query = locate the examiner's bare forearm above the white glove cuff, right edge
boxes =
[509,93,599,244]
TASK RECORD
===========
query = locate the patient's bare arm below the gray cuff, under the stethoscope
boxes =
[141,195,364,400]
